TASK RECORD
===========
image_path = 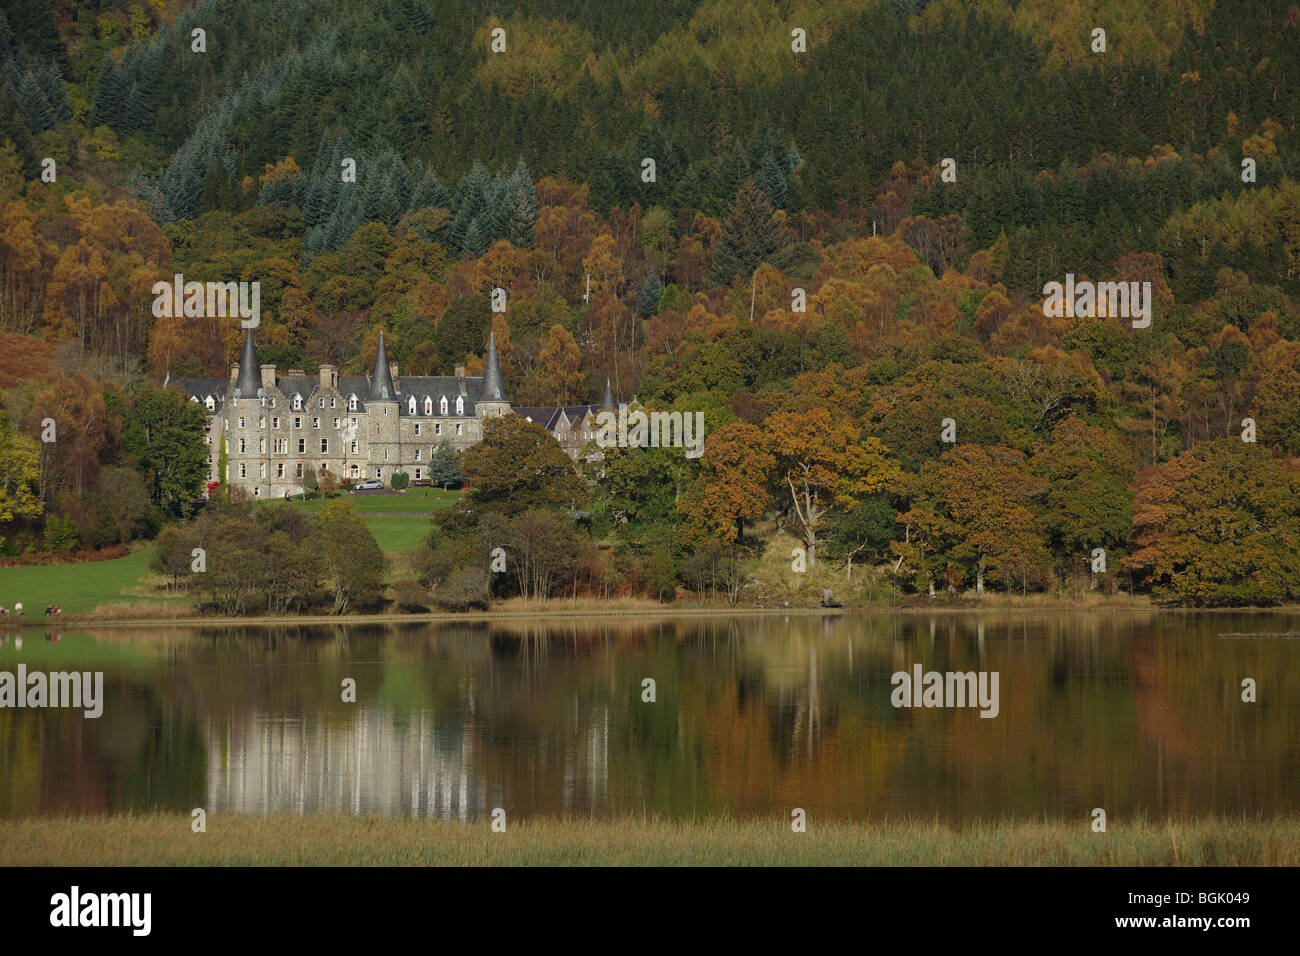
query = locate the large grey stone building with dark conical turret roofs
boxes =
[172,329,616,498]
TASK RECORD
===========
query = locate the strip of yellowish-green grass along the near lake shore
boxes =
[0,814,1300,866]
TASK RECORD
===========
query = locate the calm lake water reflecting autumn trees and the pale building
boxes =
[0,613,1300,821]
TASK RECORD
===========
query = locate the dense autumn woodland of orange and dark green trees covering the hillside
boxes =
[0,0,1300,610]
